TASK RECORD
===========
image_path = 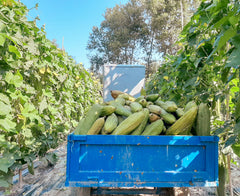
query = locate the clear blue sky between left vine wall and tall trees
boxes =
[21,0,128,68]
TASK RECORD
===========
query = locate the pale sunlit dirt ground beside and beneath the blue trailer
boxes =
[0,144,240,196]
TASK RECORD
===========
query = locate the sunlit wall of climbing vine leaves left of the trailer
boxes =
[0,0,100,186]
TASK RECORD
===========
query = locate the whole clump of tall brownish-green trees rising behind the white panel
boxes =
[87,0,199,75]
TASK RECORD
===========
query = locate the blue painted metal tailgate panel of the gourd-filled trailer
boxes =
[66,134,218,187]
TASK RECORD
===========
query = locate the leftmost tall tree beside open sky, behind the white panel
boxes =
[87,0,144,71]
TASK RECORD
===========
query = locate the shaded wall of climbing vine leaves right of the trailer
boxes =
[147,0,240,156]
